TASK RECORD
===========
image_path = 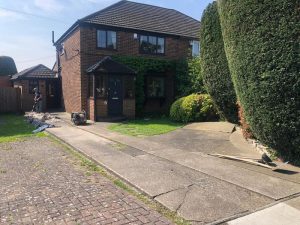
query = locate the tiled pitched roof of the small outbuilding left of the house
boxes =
[11,64,57,80]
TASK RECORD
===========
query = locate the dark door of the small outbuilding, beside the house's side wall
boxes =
[46,79,61,109]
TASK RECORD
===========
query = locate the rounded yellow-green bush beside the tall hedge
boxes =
[170,94,217,123]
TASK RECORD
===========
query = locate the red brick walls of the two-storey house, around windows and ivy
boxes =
[60,26,189,116]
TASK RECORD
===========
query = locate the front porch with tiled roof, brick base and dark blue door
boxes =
[87,56,136,121]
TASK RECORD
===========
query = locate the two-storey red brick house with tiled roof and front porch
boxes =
[54,0,200,121]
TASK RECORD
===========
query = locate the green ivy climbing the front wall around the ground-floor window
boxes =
[112,56,204,116]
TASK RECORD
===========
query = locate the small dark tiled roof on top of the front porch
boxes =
[86,56,136,75]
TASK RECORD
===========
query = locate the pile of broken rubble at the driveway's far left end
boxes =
[25,112,60,133]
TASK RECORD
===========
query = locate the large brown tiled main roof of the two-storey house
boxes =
[56,0,200,43]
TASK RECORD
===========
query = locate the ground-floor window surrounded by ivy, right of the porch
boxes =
[146,77,165,98]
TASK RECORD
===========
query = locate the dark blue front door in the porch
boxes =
[107,76,123,116]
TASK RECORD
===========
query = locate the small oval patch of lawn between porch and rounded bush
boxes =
[108,118,184,136]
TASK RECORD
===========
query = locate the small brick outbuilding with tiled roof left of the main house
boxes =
[11,64,61,111]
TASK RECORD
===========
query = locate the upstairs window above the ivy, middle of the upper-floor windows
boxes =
[140,35,165,54]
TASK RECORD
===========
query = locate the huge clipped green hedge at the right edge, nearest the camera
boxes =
[218,0,300,162]
